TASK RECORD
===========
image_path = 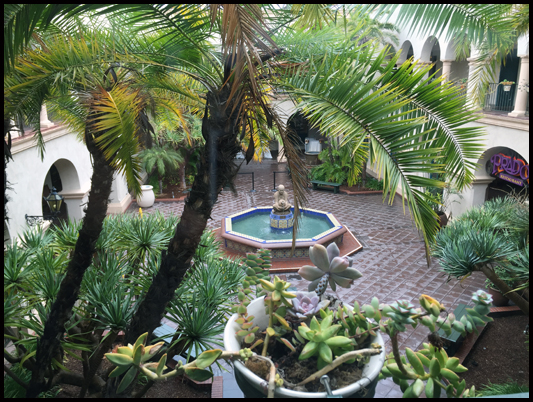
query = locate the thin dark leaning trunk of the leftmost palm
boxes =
[26,129,114,398]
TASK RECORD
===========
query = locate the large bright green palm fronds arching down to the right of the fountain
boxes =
[276,35,483,256]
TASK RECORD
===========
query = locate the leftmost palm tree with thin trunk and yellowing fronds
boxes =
[4,26,165,395]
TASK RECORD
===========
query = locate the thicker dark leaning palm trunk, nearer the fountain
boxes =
[124,88,240,344]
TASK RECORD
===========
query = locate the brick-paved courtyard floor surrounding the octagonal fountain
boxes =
[128,161,485,398]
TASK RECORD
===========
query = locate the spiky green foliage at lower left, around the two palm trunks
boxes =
[4,213,245,395]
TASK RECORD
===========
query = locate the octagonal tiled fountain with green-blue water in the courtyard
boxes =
[221,185,355,259]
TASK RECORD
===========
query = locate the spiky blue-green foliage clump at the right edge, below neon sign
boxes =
[433,197,529,314]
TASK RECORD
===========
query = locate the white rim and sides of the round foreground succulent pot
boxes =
[224,296,385,398]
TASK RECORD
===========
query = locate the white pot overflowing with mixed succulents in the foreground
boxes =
[224,243,492,398]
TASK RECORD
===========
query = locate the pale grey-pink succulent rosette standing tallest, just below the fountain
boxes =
[298,243,362,296]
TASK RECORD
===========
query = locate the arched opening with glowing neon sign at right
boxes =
[484,147,529,201]
